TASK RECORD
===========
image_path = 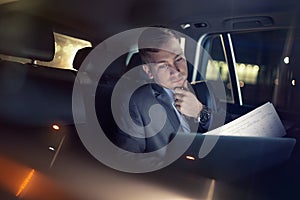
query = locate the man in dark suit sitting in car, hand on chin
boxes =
[115,28,213,153]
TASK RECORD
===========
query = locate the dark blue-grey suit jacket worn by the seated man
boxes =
[114,82,214,153]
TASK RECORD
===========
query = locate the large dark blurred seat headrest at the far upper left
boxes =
[0,13,55,61]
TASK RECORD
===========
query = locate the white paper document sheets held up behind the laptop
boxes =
[205,102,286,137]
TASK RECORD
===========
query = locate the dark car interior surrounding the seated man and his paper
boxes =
[0,0,300,200]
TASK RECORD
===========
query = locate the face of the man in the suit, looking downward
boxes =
[143,38,187,89]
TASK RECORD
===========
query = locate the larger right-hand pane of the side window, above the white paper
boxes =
[231,29,287,105]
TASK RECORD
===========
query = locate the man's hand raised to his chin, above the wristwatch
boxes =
[174,87,203,118]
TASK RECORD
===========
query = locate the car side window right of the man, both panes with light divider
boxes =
[199,29,292,110]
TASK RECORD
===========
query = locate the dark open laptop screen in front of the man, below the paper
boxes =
[167,133,296,181]
